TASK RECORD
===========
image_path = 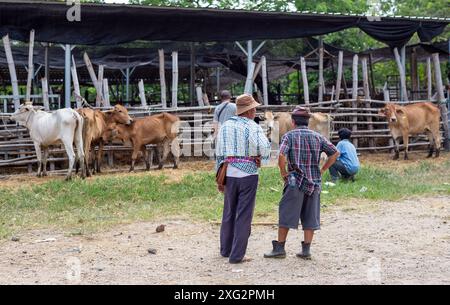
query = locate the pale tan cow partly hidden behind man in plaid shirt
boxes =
[264,111,333,143]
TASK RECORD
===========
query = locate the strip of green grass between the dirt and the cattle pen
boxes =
[0,161,450,238]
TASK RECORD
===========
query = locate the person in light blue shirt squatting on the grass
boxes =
[330,128,359,182]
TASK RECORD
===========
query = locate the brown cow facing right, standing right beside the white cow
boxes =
[77,105,133,176]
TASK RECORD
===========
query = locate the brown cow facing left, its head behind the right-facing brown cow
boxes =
[103,113,180,172]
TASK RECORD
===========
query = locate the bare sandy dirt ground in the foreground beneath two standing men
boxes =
[0,196,450,284]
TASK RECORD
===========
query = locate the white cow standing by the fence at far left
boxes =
[11,103,85,180]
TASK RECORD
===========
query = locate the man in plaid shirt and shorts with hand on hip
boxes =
[264,107,339,259]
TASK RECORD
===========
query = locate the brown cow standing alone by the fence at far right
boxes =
[378,103,441,160]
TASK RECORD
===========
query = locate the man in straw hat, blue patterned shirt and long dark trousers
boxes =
[216,94,270,264]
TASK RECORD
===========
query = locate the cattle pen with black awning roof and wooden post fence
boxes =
[0,1,450,171]
